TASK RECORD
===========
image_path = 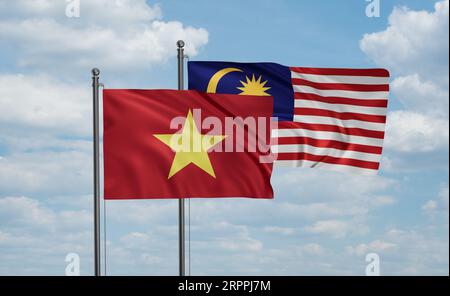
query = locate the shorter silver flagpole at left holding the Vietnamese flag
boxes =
[92,68,101,276]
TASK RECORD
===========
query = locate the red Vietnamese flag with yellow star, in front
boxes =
[103,89,273,199]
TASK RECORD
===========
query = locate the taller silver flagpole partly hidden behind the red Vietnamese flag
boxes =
[177,40,186,276]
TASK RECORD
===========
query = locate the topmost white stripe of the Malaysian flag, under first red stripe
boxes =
[291,71,389,85]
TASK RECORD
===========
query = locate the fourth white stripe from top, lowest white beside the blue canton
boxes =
[294,115,386,132]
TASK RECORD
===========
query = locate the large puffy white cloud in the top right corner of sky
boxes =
[360,0,449,82]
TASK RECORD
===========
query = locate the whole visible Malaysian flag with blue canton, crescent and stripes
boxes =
[188,62,389,173]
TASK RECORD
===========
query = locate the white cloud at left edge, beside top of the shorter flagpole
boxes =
[0,74,92,135]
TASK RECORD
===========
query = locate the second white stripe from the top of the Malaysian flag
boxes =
[293,85,389,100]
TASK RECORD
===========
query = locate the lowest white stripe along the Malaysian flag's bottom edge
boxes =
[274,160,378,175]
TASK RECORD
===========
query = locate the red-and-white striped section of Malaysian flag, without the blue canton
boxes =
[272,67,389,173]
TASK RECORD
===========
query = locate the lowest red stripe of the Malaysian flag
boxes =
[276,152,380,170]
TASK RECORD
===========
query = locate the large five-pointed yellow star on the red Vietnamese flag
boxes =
[154,110,226,179]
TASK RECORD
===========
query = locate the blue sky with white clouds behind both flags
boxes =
[0,0,449,275]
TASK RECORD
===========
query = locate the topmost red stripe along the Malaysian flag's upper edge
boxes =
[290,67,389,77]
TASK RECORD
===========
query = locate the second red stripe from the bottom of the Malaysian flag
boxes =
[272,137,383,154]
